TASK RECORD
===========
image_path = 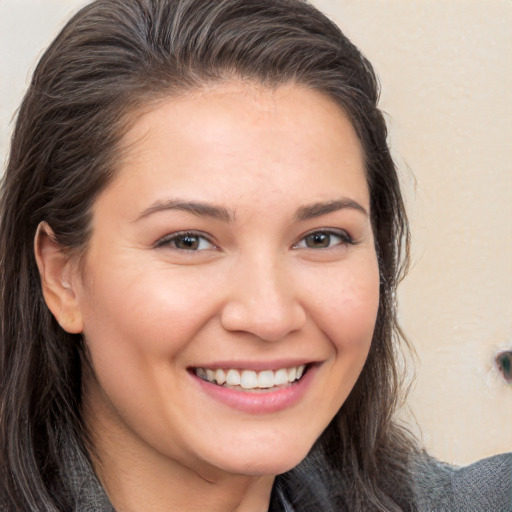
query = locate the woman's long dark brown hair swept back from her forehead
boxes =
[0,0,415,512]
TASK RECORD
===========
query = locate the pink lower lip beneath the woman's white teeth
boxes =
[190,366,318,414]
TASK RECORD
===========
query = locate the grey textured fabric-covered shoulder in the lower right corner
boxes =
[414,453,512,512]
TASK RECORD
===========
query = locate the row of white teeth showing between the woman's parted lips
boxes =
[192,364,308,392]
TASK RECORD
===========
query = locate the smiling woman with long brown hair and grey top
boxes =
[0,0,510,512]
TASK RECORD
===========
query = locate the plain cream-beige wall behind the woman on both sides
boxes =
[0,0,512,463]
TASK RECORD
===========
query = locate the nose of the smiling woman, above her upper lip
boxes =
[221,255,306,341]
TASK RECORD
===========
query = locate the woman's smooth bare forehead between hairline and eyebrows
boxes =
[105,82,368,216]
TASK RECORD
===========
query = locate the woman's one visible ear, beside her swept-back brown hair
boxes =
[34,222,83,334]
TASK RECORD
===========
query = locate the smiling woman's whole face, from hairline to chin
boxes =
[73,82,379,475]
